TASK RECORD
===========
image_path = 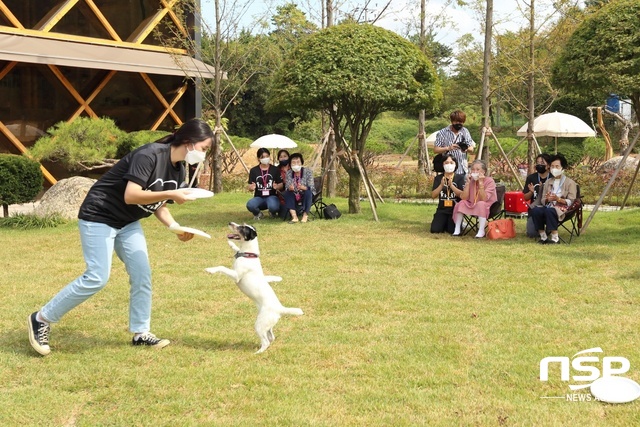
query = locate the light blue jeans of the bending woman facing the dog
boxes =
[41,220,151,333]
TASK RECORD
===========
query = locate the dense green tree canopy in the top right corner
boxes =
[553,0,640,121]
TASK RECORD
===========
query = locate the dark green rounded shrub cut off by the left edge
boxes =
[0,154,43,210]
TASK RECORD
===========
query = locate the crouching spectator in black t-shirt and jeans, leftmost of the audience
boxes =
[247,148,282,220]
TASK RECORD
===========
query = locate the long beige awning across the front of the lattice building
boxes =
[0,34,214,79]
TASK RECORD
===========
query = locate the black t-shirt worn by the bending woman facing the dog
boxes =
[78,143,185,228]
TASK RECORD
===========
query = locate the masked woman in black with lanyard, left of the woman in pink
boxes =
[431,153,464,234]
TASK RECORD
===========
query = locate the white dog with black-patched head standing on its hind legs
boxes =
[205,222,304,353]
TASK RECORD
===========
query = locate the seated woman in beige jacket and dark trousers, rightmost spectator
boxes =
[531,153,578,244]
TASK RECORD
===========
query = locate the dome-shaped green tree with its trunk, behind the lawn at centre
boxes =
[268,23,441,213]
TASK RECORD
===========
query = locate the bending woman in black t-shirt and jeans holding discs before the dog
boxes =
[27,119,213,356]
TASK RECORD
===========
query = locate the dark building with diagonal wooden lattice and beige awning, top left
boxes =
[0,0,213,184]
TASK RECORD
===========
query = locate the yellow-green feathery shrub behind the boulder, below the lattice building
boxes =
[31,117,127,171]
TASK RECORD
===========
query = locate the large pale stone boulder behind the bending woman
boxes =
[34,176,96,219]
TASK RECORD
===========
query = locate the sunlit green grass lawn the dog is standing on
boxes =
[0,194,640,426]
